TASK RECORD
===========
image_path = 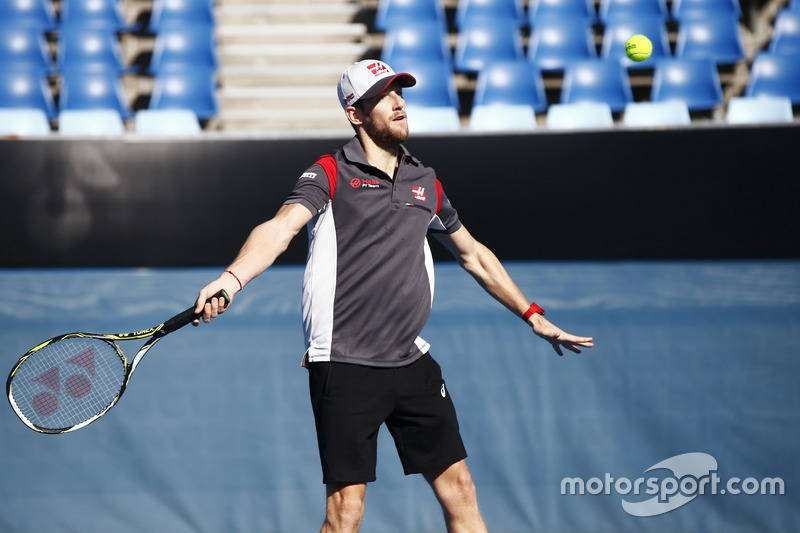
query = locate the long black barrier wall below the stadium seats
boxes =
[0,124,800,267]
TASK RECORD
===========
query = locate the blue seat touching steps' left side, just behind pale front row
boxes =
[149,68,219,120]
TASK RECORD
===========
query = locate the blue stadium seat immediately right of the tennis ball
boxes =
[675,14,745,65]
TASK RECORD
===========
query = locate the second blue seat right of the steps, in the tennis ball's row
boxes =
[454,17,525,72]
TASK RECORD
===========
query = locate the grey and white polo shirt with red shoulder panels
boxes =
[284,138,461,367]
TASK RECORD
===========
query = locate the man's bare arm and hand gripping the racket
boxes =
[194,203,314,325]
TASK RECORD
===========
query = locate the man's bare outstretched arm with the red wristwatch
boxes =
[434,226,594,355]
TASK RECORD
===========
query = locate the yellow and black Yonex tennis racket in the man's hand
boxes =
[6,290,231,433]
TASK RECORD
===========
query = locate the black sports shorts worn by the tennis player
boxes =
[308,354,467,483]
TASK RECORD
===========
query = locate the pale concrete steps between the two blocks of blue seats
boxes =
[217,0,369,133]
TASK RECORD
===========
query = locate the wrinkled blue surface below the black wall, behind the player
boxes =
[0,261,800,533]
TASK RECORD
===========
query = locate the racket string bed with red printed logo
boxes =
[10,337,126,430]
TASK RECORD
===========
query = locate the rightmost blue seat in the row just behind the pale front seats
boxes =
[744,52,800,105]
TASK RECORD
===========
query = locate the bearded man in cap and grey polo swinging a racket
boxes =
[195,60,593,532]
